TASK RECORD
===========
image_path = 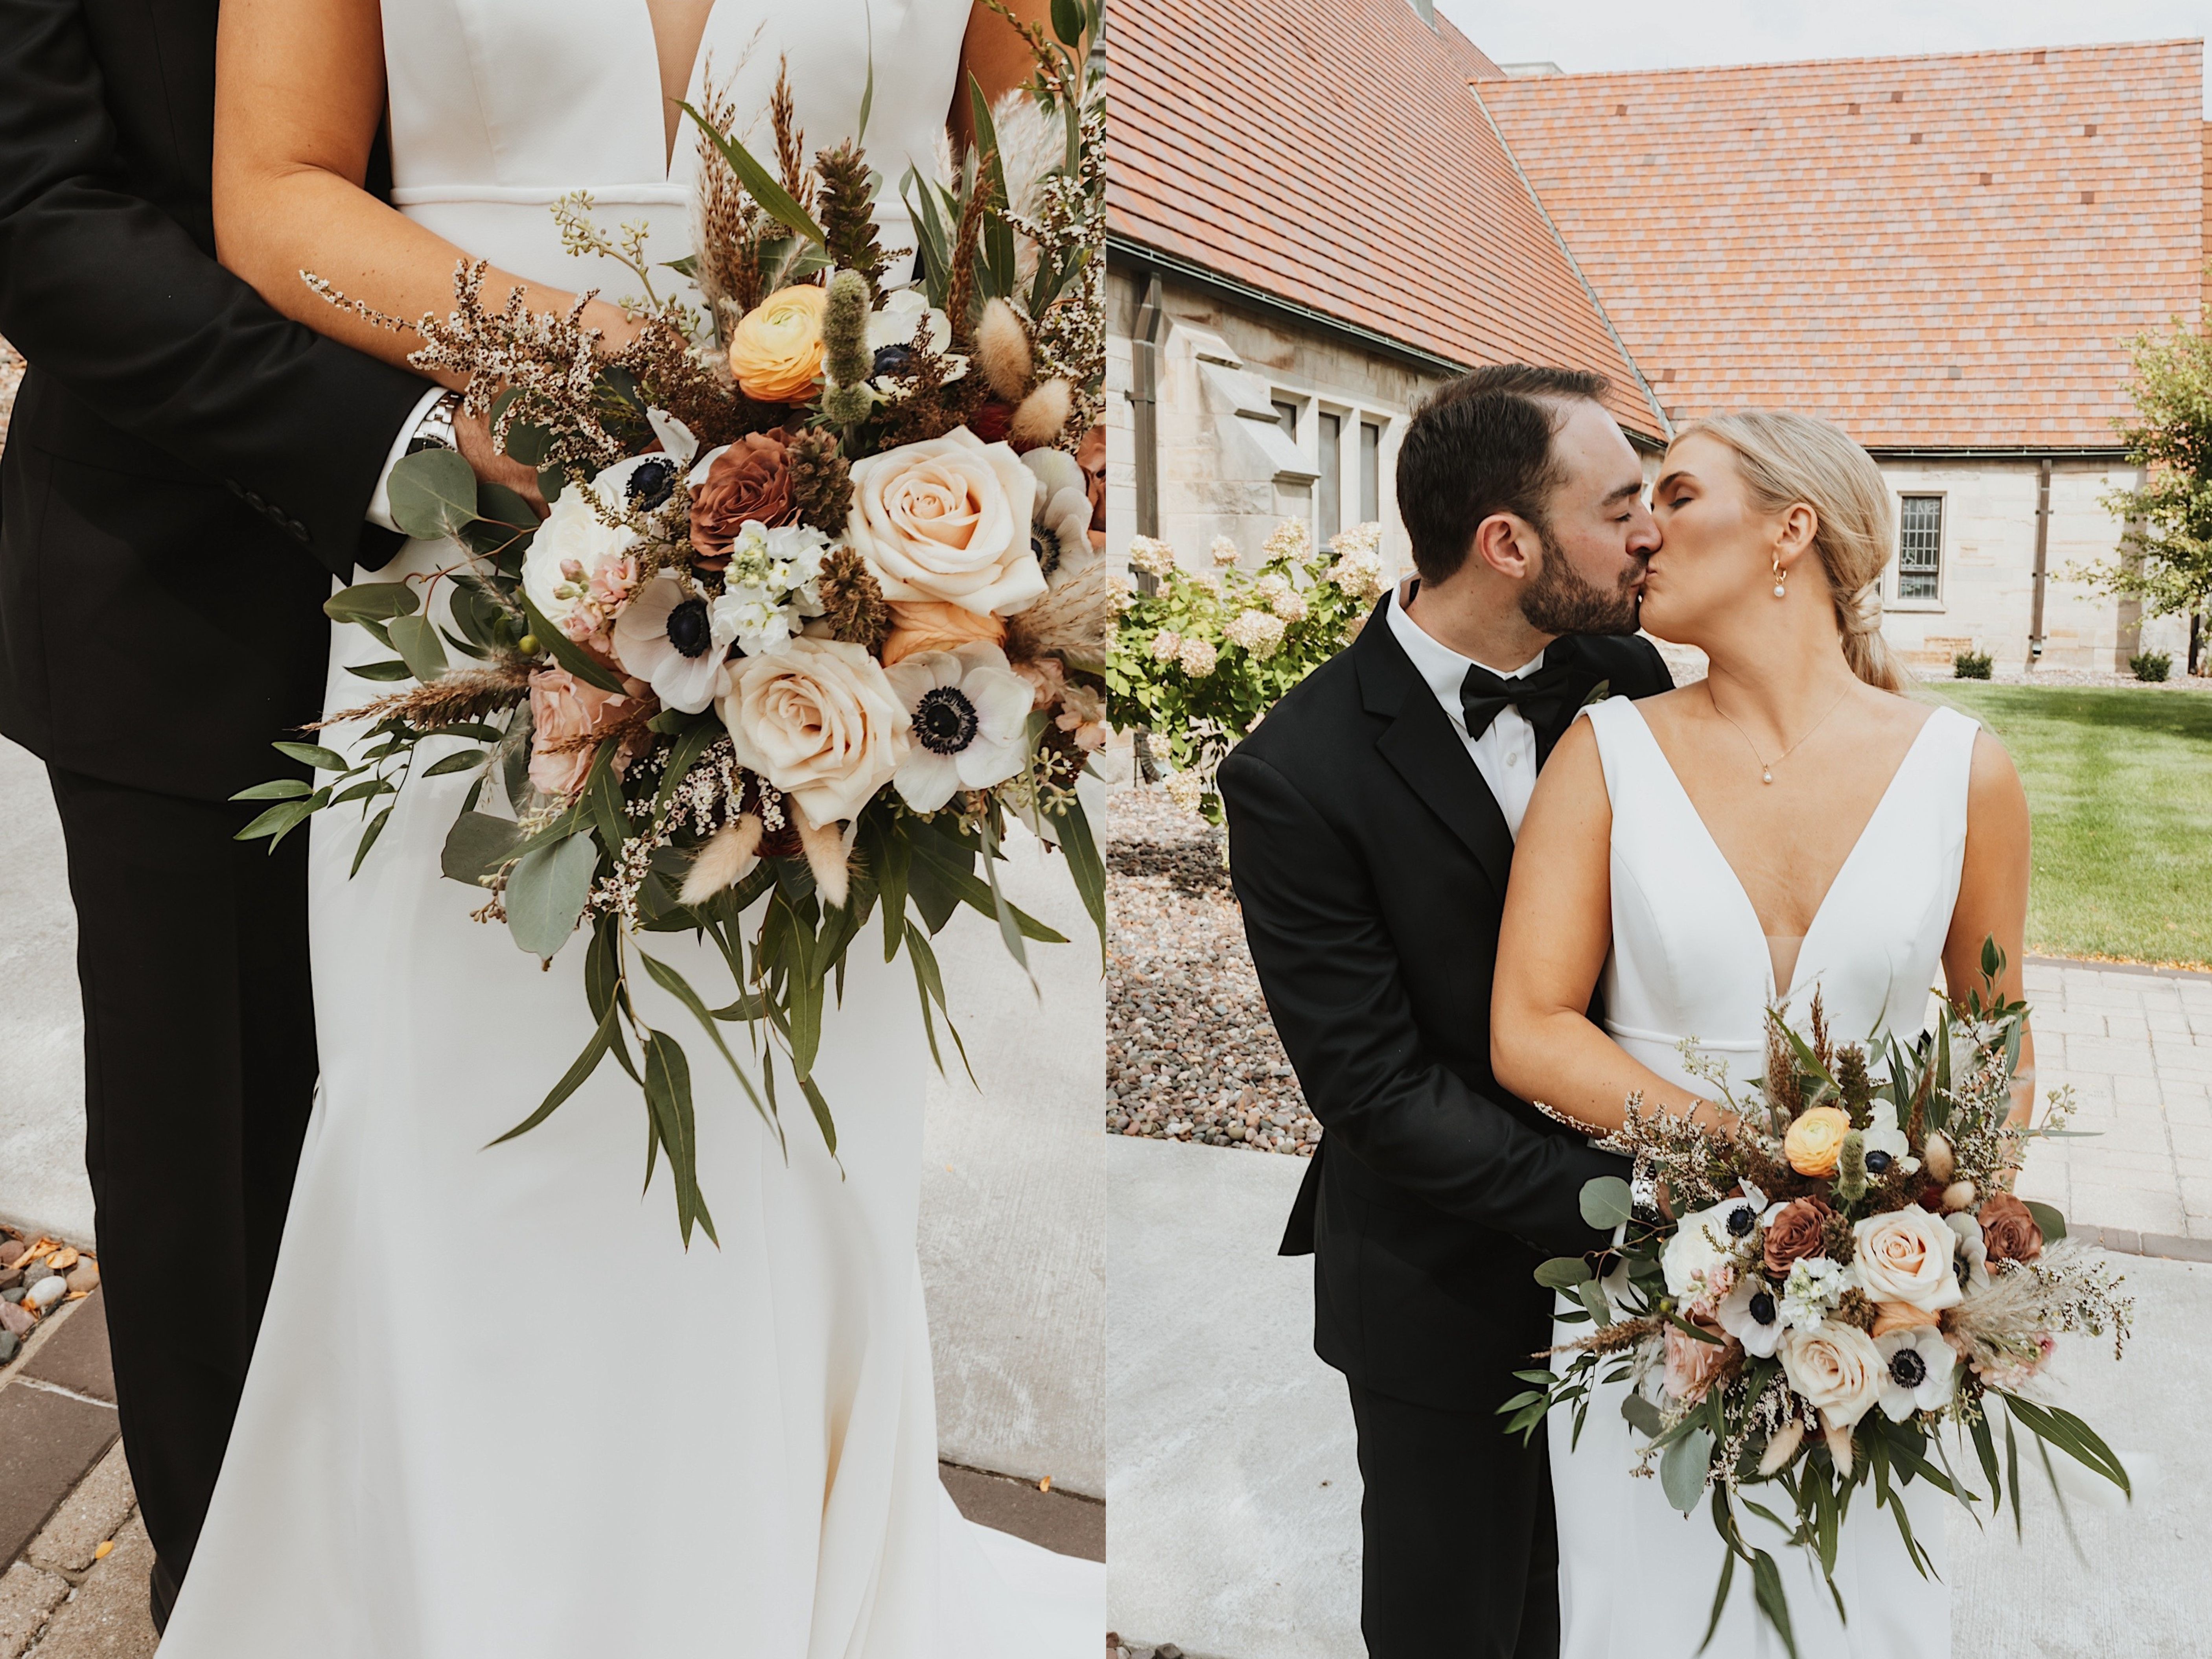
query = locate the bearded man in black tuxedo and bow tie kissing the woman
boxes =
[1219,365,1672,1659]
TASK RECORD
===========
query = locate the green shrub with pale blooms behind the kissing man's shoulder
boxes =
[1106,517,1383,823]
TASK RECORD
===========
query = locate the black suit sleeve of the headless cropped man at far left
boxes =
[0,0,427,577]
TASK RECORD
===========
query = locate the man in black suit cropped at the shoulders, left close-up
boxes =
[0,0,497,1621]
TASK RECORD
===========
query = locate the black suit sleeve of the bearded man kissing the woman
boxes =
[1219,750,1628,1254]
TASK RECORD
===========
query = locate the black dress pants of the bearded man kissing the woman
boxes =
[1352,1383,1560,1659]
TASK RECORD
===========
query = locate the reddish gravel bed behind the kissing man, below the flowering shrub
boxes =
[1106,788,1321,1157]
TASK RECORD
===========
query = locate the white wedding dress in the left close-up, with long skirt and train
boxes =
[164,0,1106,1659]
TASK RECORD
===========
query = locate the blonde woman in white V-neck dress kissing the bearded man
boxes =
[1491,414,2033,1659]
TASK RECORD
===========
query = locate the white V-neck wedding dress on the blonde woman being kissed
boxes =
[1549,697,1978,1659]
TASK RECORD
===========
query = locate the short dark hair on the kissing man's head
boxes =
[1398,363,1610,582]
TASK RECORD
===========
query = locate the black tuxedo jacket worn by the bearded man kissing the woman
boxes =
[1219,597,1672,1411]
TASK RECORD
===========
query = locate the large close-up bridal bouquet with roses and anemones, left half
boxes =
[241,0,1126,1243]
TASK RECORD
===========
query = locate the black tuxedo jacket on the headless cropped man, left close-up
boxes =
[0,0,427,799]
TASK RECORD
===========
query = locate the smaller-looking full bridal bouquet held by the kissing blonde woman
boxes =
[1504,942,2133,1652]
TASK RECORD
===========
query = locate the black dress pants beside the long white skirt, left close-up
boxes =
[51,774,316,1579]
